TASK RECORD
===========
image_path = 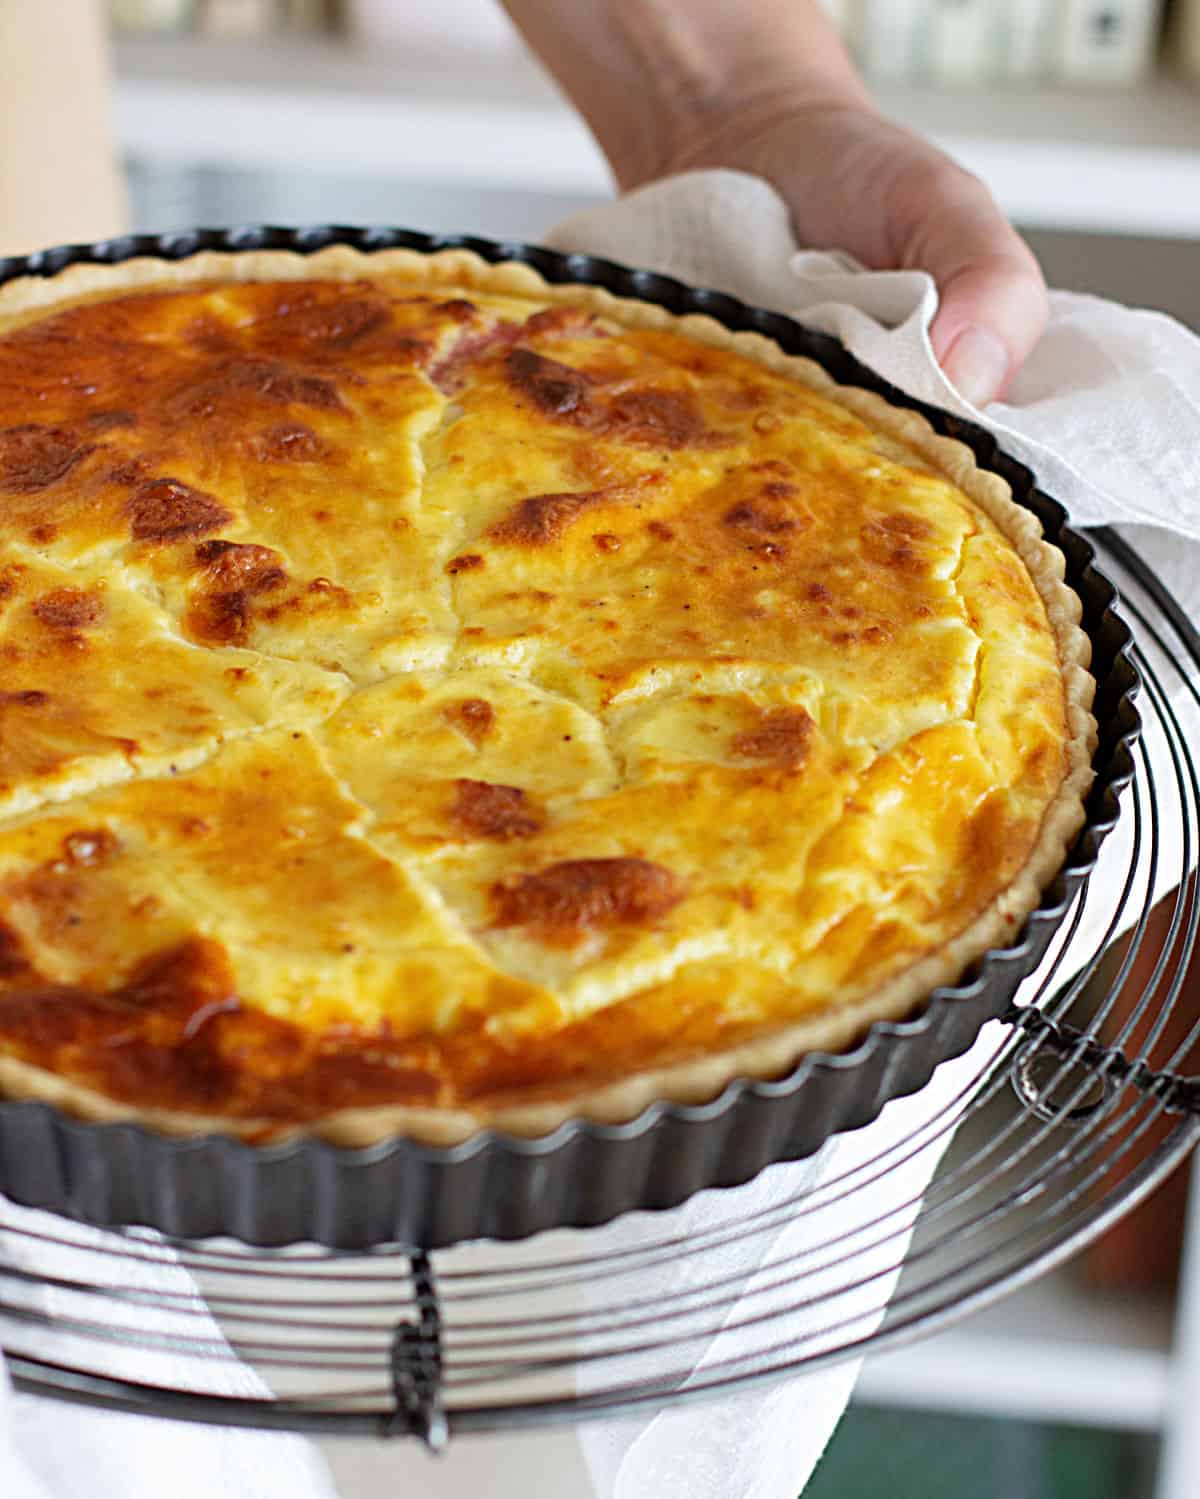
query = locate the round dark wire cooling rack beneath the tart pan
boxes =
[0,531,1200,1448]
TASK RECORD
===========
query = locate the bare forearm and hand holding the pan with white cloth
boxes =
[505,0,1047,405]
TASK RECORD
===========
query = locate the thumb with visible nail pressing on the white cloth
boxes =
[893,159,1047,406]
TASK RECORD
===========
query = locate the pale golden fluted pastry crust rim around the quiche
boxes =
[0,246,1097,1147]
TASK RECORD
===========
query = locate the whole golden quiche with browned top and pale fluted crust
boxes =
[0,247,1095,1144]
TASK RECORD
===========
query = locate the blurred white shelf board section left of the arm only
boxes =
[115,37,611,195]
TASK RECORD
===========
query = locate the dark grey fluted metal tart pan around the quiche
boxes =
[0,225,1140,1250]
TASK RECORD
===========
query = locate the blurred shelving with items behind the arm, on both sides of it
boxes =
[111,0,1200,327]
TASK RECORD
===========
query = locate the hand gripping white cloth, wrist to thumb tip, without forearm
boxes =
[668,102,1047,406]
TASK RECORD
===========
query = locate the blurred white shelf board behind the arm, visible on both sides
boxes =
[115,37,1200,238]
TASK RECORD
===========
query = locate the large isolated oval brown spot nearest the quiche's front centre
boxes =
[491,859,683,940]
